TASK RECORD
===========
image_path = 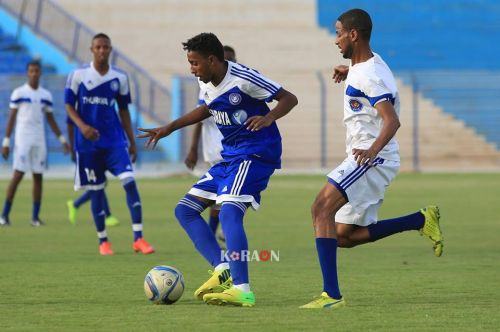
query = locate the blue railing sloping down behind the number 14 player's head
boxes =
[0,0,171,123]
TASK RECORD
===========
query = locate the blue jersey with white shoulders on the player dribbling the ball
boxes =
[199,61,282,168]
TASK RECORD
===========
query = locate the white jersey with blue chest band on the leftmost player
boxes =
[9,83,52,145]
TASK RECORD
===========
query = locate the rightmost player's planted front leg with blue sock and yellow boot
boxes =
[301,183,347,309]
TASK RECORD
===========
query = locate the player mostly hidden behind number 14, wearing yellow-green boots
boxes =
[66,118,120,226]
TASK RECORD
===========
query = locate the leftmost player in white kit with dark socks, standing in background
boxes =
[0,61,69,227]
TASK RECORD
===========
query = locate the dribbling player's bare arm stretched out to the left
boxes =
[137,105,210,148]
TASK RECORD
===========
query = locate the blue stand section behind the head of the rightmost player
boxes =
[318,0,500,149]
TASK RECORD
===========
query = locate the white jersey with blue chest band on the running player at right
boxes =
[344,53,400,161]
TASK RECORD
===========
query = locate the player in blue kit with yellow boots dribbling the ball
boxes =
[138,33,297,306]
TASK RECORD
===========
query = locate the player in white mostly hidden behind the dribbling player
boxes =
[184,45,236,245]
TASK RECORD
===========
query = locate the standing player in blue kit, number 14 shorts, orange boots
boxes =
[65,33,154,255]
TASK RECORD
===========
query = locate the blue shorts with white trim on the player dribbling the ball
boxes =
[188,159,275,210]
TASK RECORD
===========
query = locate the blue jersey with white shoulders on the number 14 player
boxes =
[65,63,131,152]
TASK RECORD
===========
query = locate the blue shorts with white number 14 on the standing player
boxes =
[75,147,134,190]
